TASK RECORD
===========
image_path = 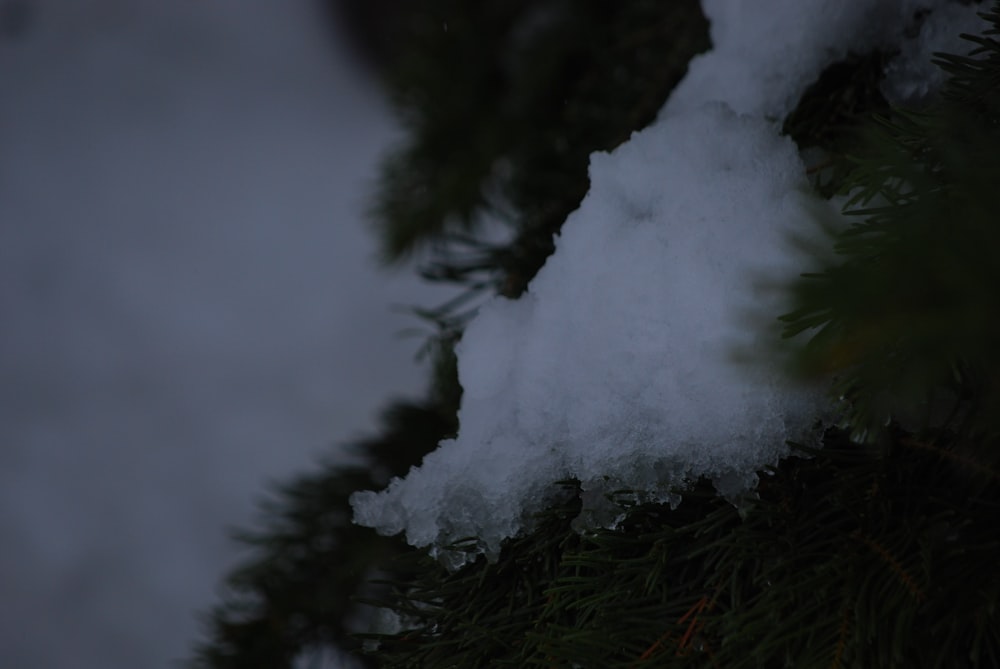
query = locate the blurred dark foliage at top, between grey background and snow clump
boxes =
[374,0,709,296]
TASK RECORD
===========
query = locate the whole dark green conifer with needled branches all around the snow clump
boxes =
[191,1,1000,668]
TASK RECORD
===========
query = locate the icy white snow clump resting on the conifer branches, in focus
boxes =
[352,0,984,567]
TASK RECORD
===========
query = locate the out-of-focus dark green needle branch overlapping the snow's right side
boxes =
[783,5,1000,446]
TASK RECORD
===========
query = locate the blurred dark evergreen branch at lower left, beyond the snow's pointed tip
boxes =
[189,392,456,669]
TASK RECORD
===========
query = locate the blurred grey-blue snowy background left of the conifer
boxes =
[0,0,440,669]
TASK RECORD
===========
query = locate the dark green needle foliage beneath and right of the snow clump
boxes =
[362,2,1000,669]
